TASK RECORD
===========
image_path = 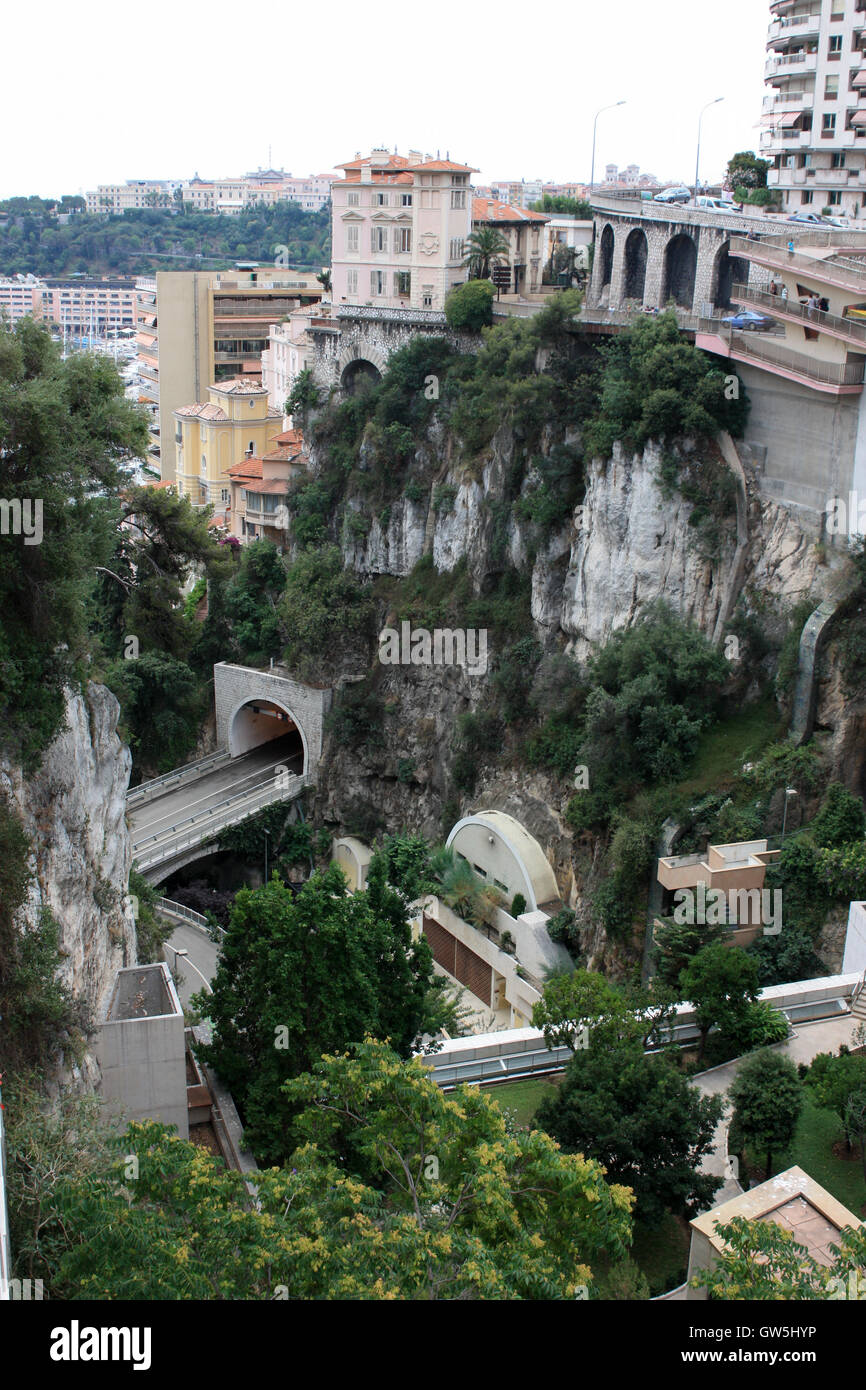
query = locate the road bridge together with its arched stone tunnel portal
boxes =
[126,662,331,883]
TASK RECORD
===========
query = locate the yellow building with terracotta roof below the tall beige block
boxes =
[174,377,282,512]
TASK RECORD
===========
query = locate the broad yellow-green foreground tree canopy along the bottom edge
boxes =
[44,1041,632,1301]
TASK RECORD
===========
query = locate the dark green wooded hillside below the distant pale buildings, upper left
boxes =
[0,199,331,275]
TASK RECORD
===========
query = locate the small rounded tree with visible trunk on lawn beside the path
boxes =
[728,1051,803,1177]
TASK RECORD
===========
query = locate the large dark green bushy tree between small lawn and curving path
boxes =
[535,1036,723,1225]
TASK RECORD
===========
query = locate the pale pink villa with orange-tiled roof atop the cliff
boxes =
[331,150,475,310]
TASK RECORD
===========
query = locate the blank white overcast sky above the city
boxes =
[0,0,770,197]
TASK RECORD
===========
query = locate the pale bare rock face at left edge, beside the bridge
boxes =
[0,684,136,1061]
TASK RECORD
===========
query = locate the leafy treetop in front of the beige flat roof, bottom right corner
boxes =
[692,1216,866,1302]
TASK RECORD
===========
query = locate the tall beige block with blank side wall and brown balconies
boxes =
[145,261,322,480]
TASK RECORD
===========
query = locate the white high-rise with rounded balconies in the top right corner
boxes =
[760,0,866,217]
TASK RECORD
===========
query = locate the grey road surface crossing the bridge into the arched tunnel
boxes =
[129,734,303,849]
